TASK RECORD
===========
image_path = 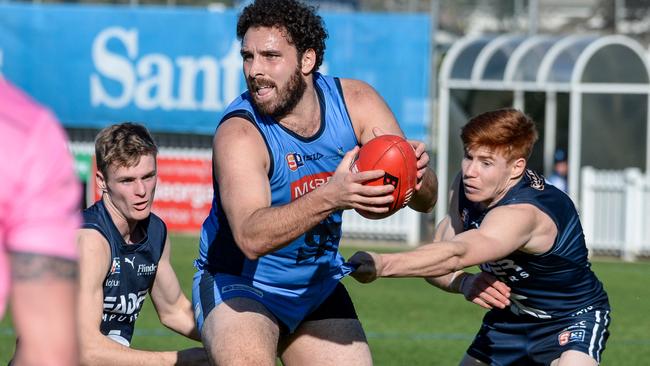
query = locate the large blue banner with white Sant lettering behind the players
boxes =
[0,4,431,140]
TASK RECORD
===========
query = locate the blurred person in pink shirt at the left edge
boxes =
[0,76,81,364]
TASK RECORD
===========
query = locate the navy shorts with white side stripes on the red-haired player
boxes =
[467,309,610,365]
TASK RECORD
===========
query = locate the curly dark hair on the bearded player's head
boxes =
[237,0,327,71]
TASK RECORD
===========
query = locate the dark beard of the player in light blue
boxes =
[246,68,307,119]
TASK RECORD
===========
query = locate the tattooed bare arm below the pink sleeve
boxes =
[9,252,77,365]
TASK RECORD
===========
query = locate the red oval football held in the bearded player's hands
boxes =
[352,135,418,220]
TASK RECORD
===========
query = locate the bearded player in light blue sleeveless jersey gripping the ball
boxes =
[193,0,437,366]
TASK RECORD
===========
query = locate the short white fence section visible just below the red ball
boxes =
[343,207,423,246]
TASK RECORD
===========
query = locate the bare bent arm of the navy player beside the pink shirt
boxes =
[77,229,207,366]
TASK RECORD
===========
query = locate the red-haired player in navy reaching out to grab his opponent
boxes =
[350,109,610,366]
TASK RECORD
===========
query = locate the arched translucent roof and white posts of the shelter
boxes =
[437,34,650,218]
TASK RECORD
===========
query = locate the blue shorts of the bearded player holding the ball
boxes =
[192,270,356,333]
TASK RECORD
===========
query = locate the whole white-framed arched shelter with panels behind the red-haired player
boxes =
[436,34,650,220]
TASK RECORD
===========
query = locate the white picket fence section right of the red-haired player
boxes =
[580,167,650,261]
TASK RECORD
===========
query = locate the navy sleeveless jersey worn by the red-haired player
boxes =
[459,170,609,319]
